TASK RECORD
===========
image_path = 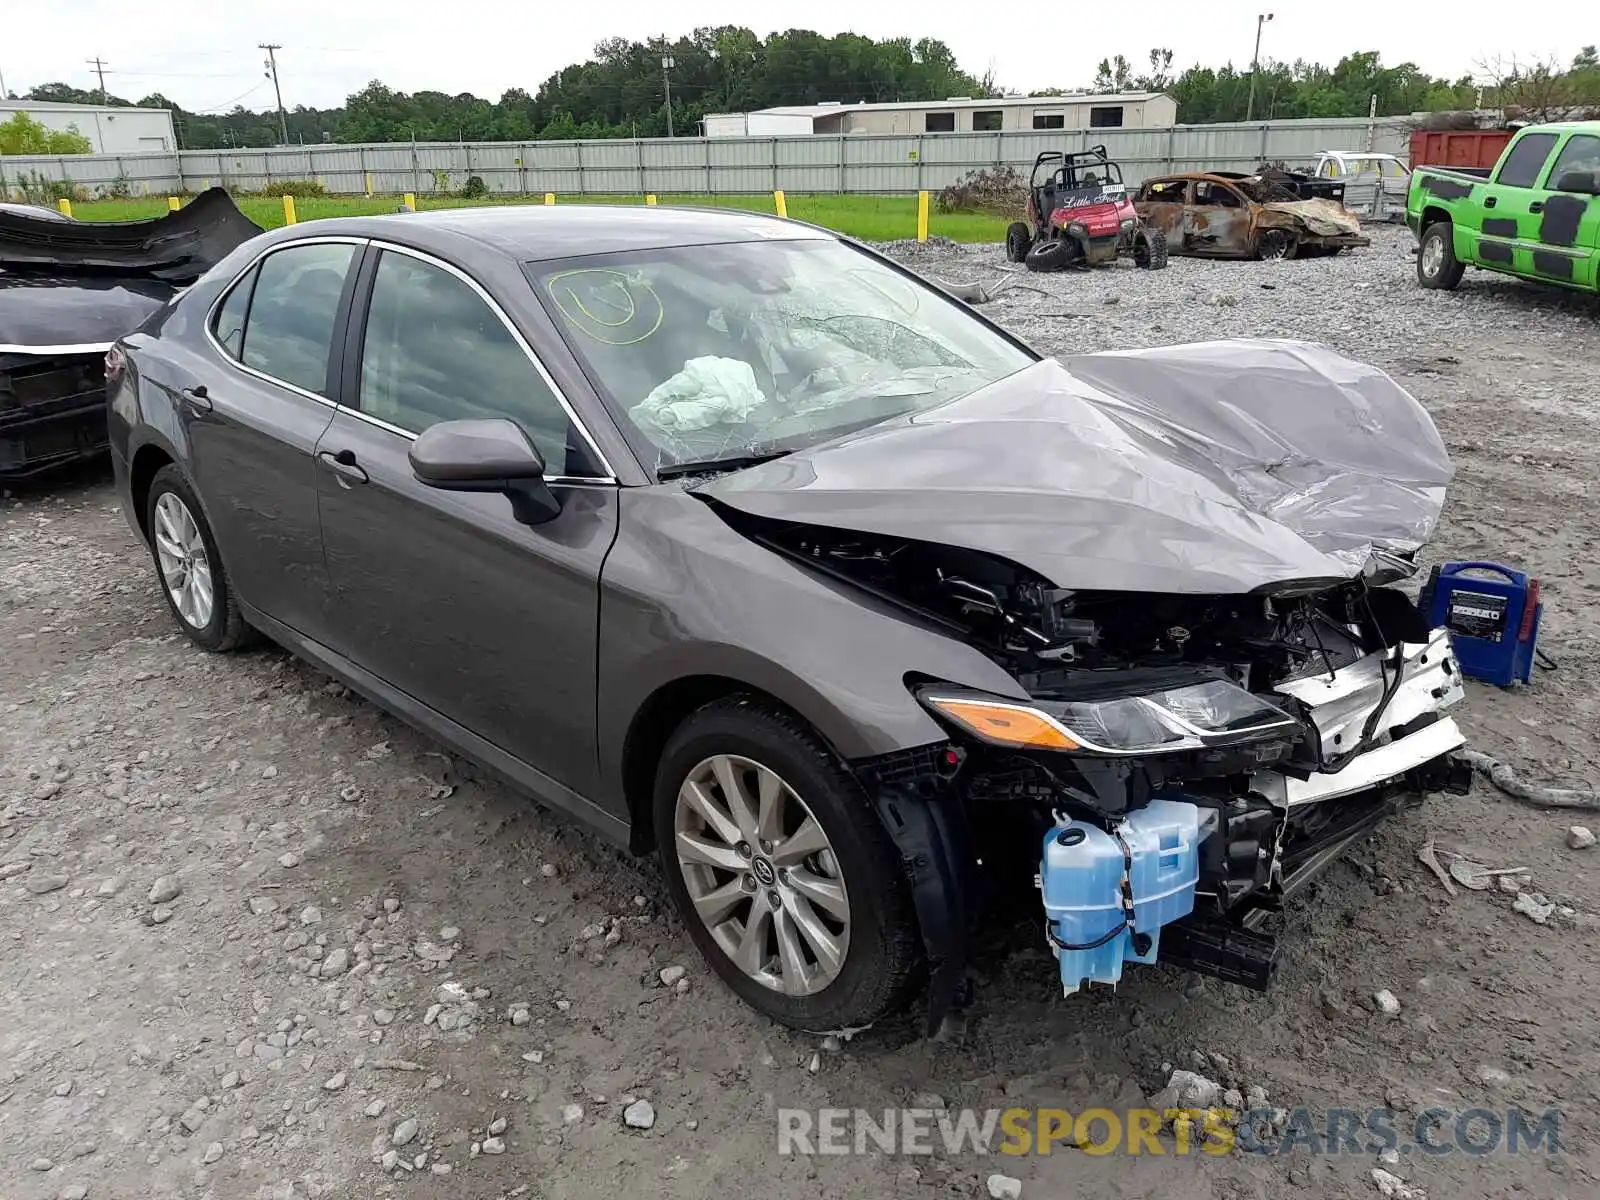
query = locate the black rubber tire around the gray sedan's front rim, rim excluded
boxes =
[654,696,922,1032]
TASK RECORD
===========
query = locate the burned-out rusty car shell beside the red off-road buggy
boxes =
[1134,171,1371,258]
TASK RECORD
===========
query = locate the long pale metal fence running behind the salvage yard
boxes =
[0,117,1410,195]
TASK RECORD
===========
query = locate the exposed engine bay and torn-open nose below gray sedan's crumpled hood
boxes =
[731,514,1470,1017]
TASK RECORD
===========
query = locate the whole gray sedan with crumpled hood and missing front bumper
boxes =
[107,206,1469,1029]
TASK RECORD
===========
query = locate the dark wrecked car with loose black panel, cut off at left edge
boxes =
[0,189,261,480]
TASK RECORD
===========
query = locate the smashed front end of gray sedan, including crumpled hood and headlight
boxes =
[699,341,1470,1019]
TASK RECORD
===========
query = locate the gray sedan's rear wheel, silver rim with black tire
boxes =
[144,464,250,650]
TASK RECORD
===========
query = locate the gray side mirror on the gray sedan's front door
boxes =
[408,418,562,525]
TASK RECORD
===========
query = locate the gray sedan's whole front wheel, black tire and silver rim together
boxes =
[654,699,918,1030]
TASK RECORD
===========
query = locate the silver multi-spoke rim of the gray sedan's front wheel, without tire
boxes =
[674,754,850,995]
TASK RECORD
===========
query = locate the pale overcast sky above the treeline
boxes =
[0,0,1600,110]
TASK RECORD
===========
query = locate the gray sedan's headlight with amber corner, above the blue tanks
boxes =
[918,678,1302,755]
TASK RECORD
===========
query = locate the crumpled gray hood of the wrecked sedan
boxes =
[696,339,1451,594]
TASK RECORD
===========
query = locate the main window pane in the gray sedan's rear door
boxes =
[236,242,357,395]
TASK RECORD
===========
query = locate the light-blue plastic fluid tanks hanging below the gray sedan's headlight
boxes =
[1038,800,1216,995]
